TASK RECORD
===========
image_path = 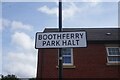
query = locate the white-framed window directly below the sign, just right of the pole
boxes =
[62,48,73,65]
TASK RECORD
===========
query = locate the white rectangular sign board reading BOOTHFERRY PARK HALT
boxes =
[35,31,87,49]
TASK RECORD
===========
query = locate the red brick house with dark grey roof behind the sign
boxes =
[37,28,120,80]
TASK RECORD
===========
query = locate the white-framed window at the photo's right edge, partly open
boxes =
[107,47,120,63]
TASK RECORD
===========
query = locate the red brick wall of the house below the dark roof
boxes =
[37,44,120,78]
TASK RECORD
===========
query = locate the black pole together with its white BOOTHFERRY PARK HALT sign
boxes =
[35,0,87,80]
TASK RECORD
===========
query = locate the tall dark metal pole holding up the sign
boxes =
[59,0,63,80]
